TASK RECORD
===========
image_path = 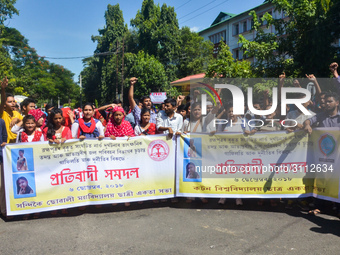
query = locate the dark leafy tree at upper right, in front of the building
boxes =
[239,0,340,77]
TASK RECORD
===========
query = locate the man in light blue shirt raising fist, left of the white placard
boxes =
[128,77,157,125]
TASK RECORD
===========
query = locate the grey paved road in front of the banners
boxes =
[0,199,340,255]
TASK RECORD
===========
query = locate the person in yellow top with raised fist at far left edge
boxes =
[0,77,23,143]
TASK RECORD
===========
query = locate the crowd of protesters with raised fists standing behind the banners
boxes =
[0,63,340,219]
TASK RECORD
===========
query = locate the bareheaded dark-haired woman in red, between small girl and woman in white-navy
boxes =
[44,108,72,144]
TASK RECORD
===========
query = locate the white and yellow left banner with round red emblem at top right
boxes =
[4,135,175,215]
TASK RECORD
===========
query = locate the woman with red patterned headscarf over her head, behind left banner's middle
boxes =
[105,106,135,140]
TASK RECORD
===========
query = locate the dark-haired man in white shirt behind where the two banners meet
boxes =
[156,98,183,138]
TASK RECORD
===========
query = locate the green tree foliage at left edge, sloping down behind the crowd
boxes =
[0,27,79,104]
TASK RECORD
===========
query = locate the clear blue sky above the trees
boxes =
[5,0,264,82]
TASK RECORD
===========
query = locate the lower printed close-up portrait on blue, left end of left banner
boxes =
[13,173,36,198]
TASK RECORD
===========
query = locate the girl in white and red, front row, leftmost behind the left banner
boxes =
[17,115,45,143]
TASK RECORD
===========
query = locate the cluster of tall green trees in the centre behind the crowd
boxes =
[82,0,213,104]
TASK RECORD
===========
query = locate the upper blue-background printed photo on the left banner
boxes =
[11,148,34,172]
